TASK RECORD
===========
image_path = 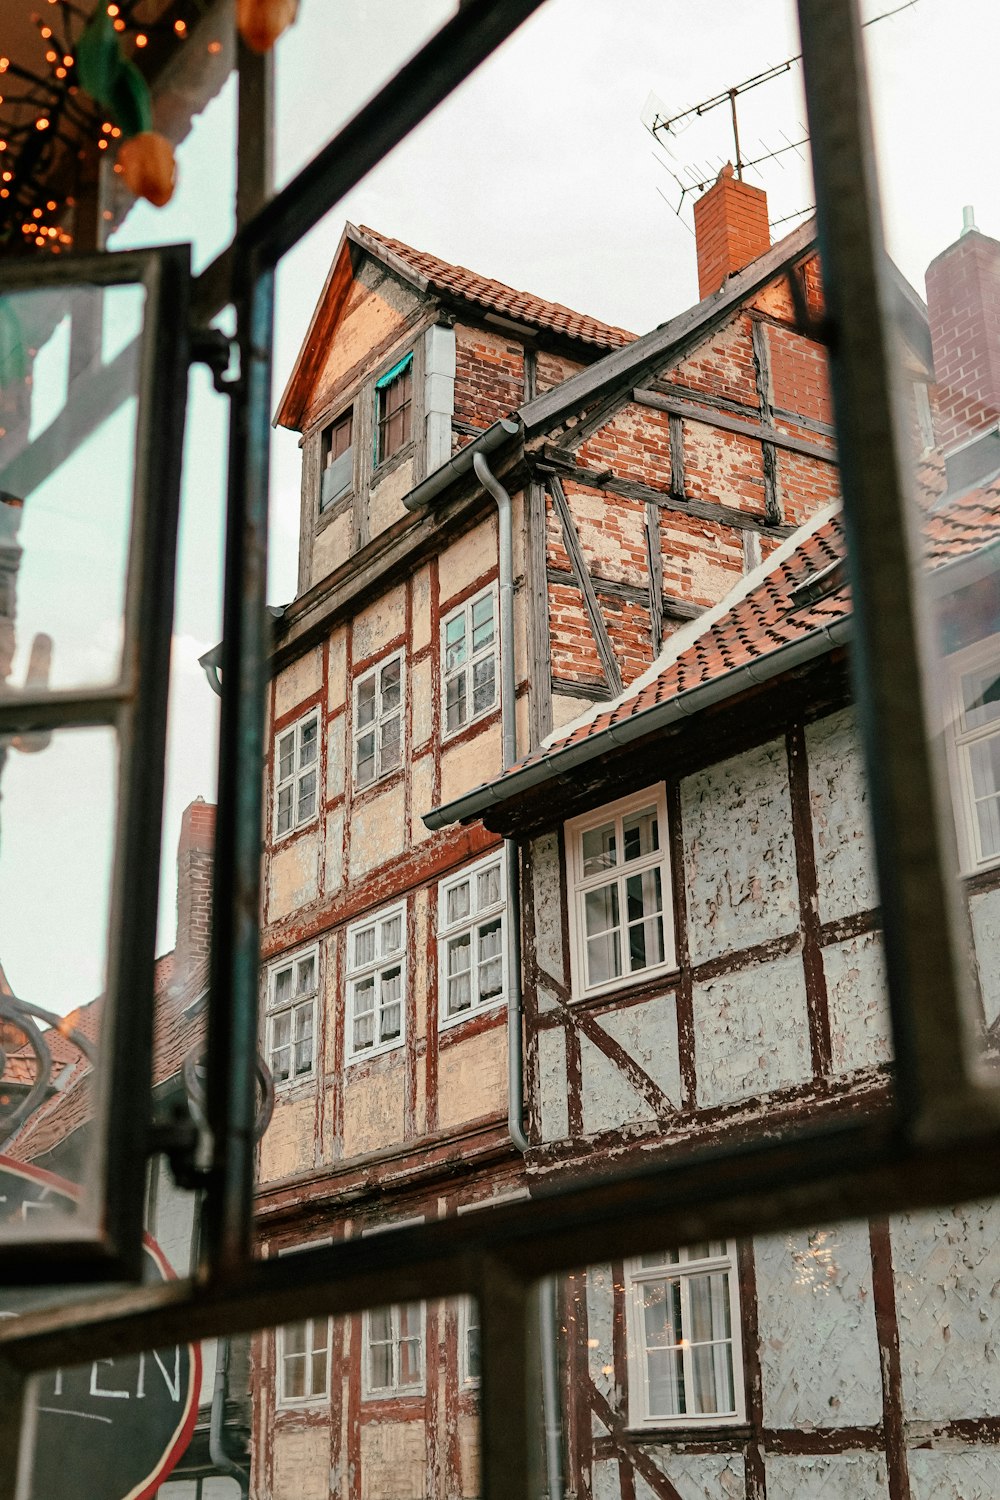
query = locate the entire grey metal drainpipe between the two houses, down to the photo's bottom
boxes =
[472,453,562,1500]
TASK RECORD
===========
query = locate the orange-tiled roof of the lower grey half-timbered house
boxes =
[424,459,1000,828]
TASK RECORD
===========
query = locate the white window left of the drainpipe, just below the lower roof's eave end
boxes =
[438,849,507,1026]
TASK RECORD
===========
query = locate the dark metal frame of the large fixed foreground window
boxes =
[0,0,1000,1500]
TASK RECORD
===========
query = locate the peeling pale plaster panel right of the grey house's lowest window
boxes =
[754,1224,882,1430]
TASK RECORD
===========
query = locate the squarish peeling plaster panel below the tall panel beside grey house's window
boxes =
[694,953,813,1107]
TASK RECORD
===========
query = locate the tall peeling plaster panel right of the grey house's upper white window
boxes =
[681,741,799,963]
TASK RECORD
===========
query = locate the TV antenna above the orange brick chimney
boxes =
[642,0,918,222]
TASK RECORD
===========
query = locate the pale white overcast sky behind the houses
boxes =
[0,0,1000,1011]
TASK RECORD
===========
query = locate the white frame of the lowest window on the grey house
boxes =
[624,1239,747,1431]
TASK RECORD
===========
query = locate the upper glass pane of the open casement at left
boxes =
[0,287,145,695]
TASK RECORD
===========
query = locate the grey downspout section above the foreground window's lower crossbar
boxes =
[472,453,528,1157]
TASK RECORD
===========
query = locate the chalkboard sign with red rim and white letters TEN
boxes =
[0,1155,201,1500]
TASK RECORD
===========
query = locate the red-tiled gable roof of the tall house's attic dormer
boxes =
[274,224,636,429]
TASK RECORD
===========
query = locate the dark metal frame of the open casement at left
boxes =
[0,246,190,1281]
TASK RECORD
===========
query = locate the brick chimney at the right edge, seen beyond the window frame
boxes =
[927,209,1000,471]
